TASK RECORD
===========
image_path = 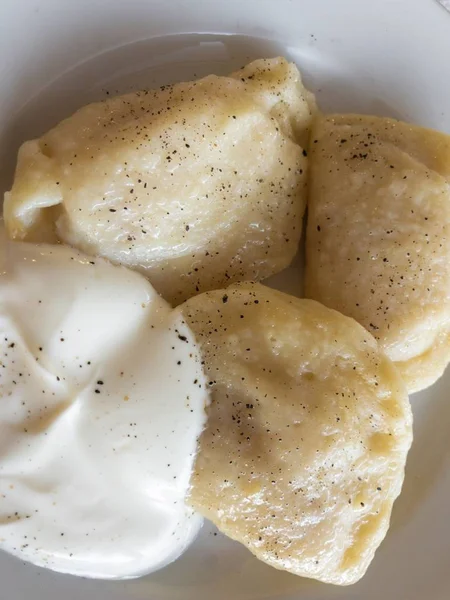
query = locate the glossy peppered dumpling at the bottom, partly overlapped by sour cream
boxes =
[177,283,412,585]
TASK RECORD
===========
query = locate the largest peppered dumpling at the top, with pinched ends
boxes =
[5,58,315,303]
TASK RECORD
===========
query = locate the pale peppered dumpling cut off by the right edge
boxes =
[306,115,450,392]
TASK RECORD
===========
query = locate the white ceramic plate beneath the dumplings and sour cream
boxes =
[0,0,450,600]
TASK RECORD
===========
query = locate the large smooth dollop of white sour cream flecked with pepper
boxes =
[0,229,208,579]
